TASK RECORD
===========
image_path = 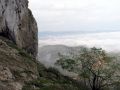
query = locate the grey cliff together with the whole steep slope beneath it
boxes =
[0,0,81,90]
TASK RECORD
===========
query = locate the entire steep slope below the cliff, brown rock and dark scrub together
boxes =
[0,37,81,90]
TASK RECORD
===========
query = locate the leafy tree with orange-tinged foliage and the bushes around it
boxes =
[56,47,120,90]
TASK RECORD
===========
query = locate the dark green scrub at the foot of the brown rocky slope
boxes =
[23,63,84,90]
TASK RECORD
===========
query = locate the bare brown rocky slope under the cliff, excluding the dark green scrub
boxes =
[0,37,38,90]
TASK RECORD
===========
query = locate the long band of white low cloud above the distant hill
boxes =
[39,32,120,51]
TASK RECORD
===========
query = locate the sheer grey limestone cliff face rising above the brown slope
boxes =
[0,0,38,56]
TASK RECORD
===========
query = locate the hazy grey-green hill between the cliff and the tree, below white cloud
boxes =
[38,45,83,67]
